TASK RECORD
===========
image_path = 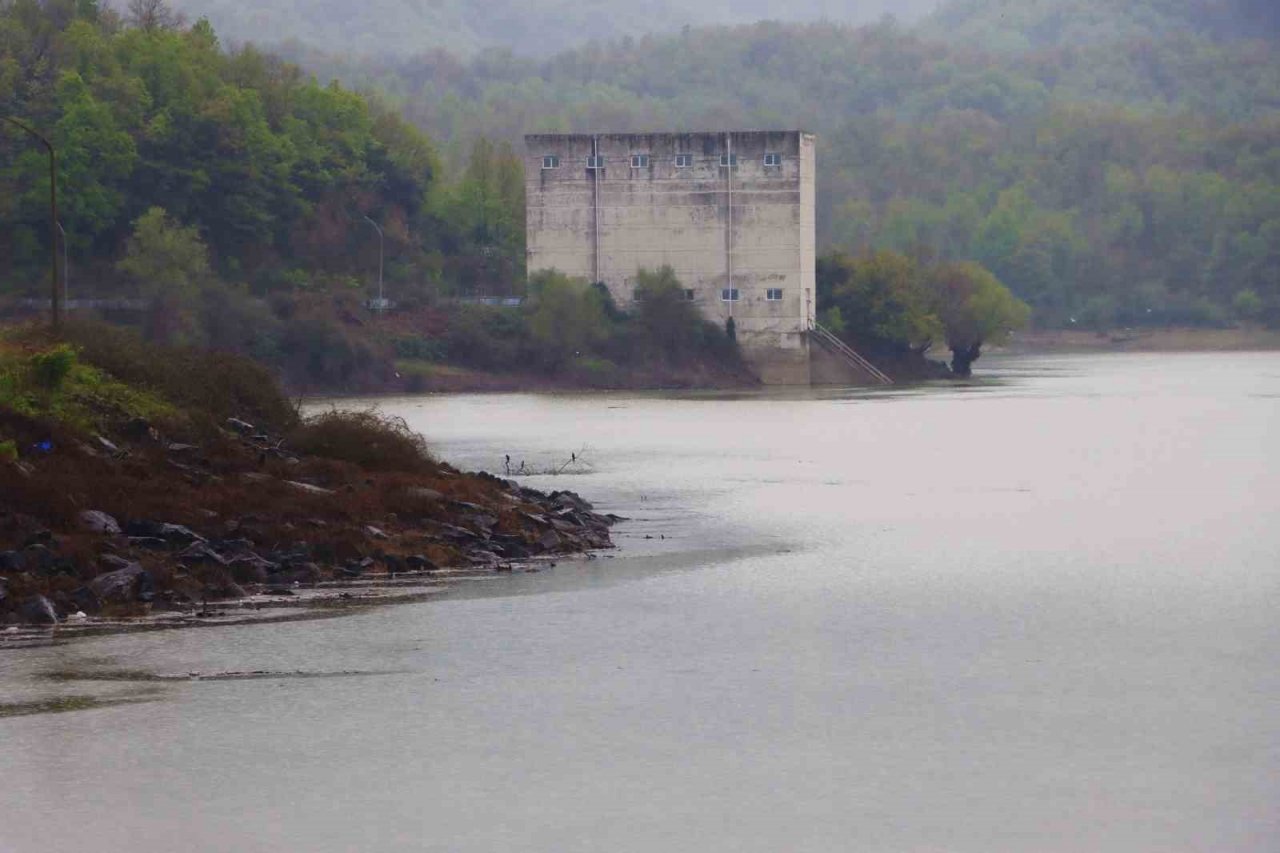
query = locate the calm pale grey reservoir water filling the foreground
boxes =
[0,353,1280,853]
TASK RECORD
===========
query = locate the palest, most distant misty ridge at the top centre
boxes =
[174,0,938,56]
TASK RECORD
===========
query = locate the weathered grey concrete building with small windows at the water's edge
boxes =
[525,131,815,384]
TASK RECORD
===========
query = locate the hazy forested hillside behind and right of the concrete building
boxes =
[305,7,1280,325]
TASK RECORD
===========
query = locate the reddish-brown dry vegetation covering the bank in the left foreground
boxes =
[0,324,619,621]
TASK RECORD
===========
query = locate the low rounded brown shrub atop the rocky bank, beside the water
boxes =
[288,410,435,471]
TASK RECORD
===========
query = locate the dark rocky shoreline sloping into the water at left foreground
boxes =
[0,419,620,634]
